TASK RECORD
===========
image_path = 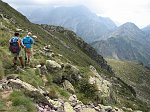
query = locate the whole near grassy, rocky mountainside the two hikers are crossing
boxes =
[0,1,149,112]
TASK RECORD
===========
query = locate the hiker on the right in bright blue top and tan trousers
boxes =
[22,32,34,65]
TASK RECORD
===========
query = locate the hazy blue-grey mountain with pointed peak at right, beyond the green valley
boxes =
[91,23,150,66]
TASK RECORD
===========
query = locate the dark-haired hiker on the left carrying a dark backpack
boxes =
[9,32,25,68]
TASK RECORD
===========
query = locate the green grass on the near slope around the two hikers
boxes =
[0,1,112,112]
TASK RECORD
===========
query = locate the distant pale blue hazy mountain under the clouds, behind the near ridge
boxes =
[18,6,116,43]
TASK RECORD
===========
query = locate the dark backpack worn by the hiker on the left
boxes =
[9,37,21,54]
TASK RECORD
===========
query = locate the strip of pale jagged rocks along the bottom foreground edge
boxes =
[0,77,142,112]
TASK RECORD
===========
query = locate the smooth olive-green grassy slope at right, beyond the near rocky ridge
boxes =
[107,59,150,103]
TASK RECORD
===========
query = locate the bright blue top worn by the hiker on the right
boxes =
[22,36,34,48]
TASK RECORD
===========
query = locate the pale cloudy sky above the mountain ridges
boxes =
[3,0,150,28]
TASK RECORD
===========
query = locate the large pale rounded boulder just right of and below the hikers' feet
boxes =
[46,60,61,72]
